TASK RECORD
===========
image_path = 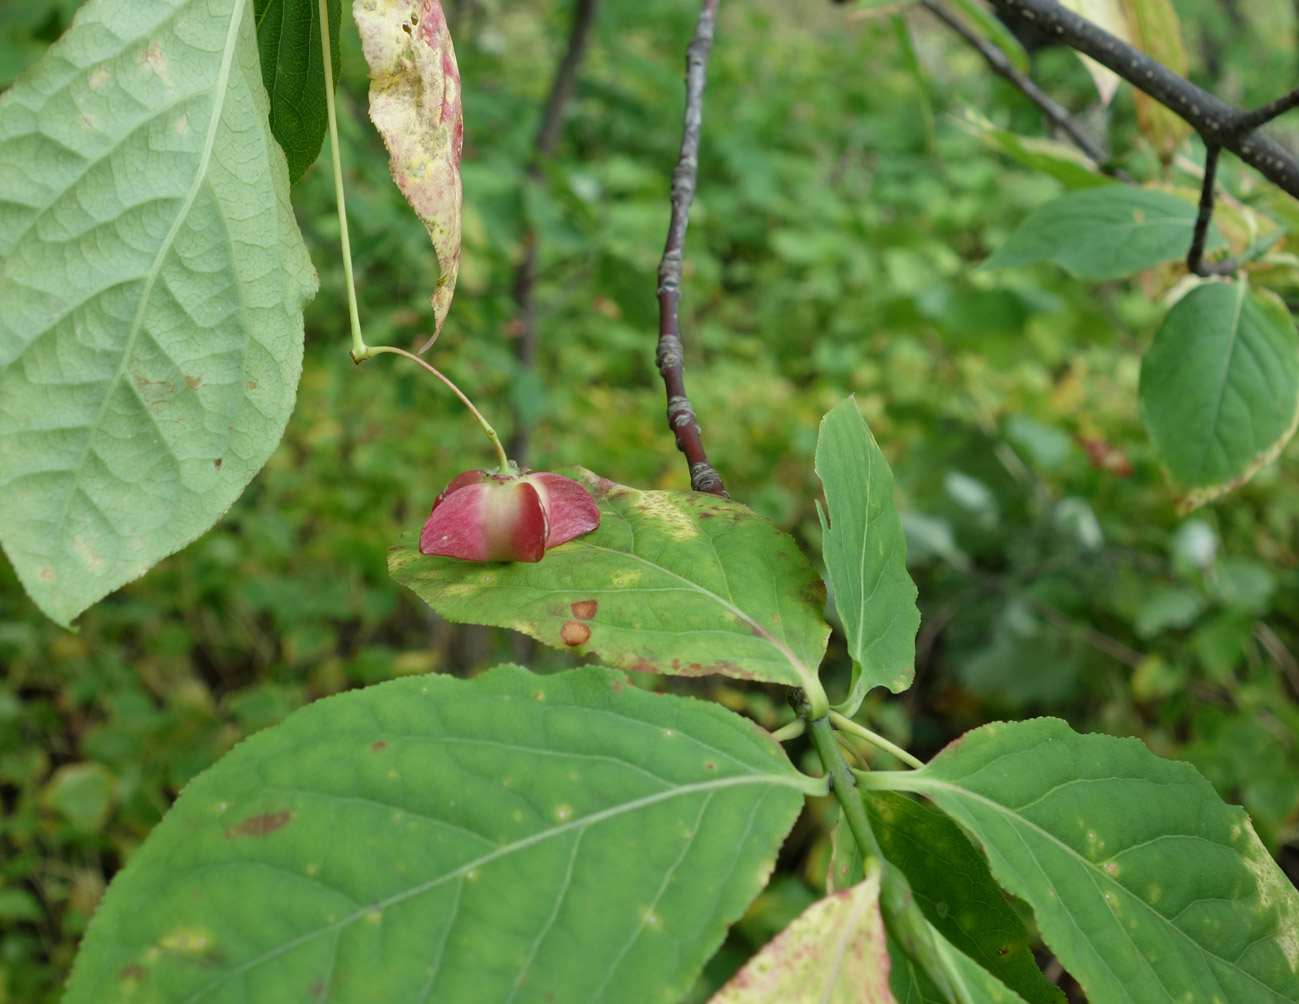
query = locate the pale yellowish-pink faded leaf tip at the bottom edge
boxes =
[709,868,896,1004]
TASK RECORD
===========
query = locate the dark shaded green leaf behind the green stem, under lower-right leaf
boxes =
[864,791,1064,1004]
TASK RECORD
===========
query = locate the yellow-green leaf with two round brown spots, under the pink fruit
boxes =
[388,468,830,691]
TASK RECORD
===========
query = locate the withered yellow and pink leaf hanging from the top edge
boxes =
[352,0,464,348]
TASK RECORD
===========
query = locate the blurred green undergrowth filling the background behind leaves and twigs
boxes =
[0,0,1299,1004]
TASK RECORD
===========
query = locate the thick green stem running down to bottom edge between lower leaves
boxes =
[803,703,969,1004]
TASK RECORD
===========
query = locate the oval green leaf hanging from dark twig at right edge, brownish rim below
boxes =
[1139,277,1299,505]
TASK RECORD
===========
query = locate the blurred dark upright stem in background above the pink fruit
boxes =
[509,0,599,465]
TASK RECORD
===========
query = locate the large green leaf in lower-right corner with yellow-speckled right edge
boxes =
[863,718,1299,1004]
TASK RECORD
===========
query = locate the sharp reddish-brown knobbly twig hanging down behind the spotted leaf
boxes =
[655,0,729,497]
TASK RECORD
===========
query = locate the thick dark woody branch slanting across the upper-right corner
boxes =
[991,0,1299,199]
